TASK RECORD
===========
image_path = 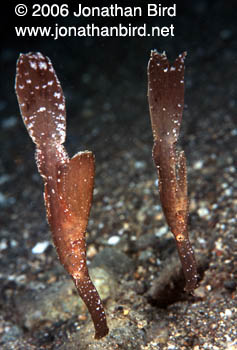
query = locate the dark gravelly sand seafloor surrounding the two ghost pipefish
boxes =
[0,0,237,350]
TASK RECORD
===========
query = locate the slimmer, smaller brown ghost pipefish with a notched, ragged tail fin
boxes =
[148,51,197,292]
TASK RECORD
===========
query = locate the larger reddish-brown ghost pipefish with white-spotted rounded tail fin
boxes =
[16,53,109,339]
